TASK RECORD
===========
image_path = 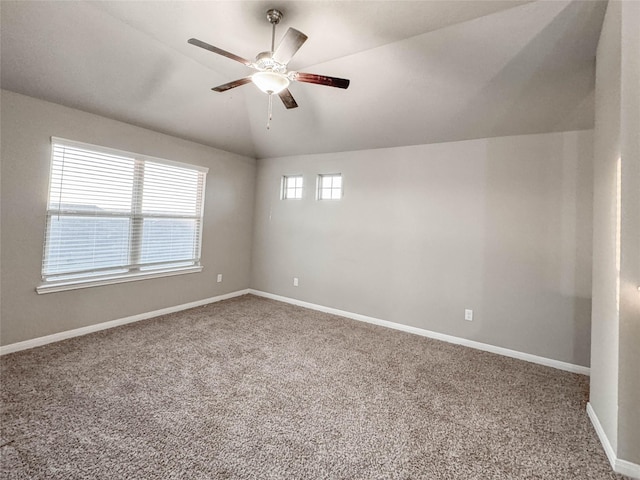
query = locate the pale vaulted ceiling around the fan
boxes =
[0,0,606,158]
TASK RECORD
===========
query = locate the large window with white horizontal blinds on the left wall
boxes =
[37,138,207,293]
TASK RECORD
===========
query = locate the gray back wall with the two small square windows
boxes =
[252,131,593,366]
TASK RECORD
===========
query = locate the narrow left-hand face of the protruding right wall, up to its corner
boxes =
[589,2,620,450]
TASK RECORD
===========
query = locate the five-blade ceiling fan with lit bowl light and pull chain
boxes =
[188,8,349,128]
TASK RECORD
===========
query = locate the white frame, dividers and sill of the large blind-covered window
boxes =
[36,137,209,294]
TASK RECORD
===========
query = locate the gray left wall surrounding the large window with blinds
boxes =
[0,91,256,345]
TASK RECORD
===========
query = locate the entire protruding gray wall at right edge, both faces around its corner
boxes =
[590,1,640,464]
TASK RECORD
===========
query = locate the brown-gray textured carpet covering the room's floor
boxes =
[0,295,623,480]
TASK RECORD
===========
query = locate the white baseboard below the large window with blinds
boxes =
[0,289,249,355]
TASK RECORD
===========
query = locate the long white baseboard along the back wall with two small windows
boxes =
[249,289,590,375]
